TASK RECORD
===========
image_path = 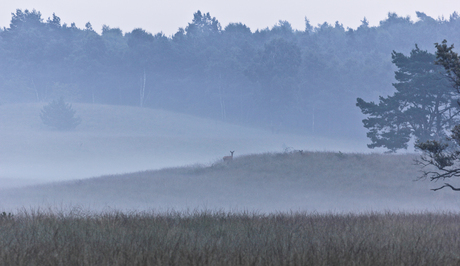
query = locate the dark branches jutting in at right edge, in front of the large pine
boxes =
[415,40,460,191]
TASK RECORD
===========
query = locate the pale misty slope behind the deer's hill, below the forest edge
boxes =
[0,104,367,187]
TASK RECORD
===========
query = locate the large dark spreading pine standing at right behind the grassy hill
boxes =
[356,45,460,152]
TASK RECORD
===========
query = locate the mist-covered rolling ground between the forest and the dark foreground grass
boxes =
[0,104,450,213]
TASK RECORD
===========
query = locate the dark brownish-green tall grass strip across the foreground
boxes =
[0,210,460,265]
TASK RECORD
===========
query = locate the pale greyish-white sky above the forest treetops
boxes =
[0,0,460,36]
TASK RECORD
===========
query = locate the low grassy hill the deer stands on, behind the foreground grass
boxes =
[0,151,460,212]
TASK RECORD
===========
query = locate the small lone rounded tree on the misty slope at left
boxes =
[40,97,81,130]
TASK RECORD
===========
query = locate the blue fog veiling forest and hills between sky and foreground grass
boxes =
[0,10,460,215]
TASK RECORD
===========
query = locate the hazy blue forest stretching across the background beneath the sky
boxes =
[0,9,460,138]
